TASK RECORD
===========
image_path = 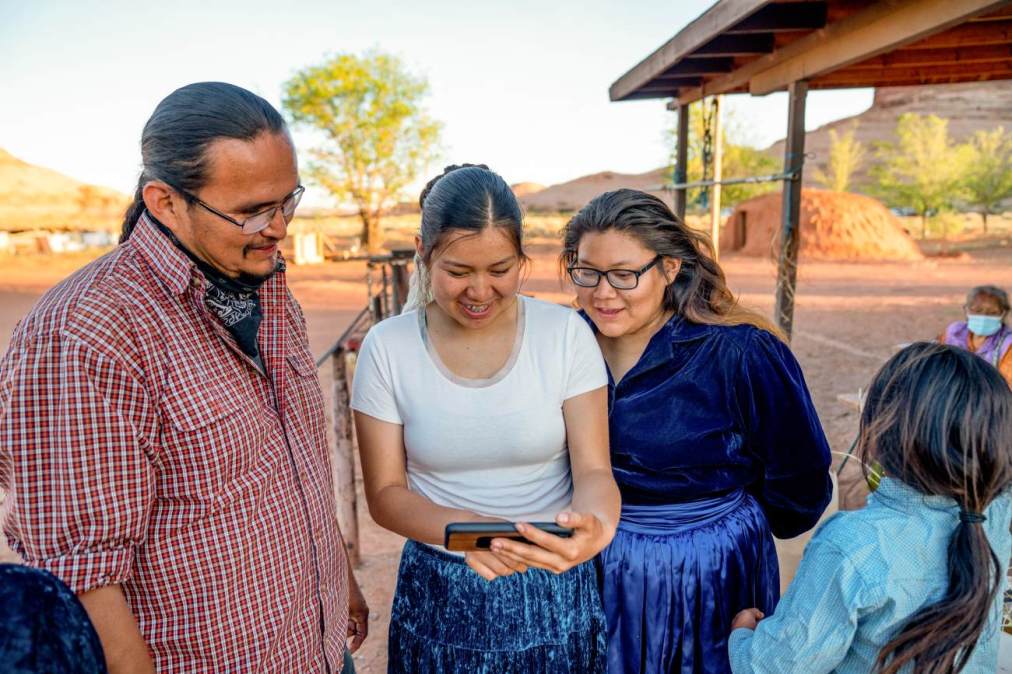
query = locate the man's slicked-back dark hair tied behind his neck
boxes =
[119,82,285,243]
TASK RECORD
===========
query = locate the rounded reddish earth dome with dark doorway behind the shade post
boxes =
[721,188,924,260]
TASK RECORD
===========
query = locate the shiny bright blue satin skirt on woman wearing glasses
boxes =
[598,490,780,674]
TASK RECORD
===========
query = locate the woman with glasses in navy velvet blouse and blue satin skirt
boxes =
[563,189,832,674]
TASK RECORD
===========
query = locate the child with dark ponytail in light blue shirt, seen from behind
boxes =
[728,342,1012,674]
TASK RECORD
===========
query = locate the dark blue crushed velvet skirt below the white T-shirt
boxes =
[388,540,606,674]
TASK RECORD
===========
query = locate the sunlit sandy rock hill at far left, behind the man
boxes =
[0,150,128,232]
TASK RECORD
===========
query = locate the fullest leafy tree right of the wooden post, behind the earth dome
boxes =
[871,112,968,239]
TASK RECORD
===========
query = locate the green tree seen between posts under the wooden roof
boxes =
[666,103,779,206]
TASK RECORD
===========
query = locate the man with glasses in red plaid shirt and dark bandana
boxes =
[0,83,368,673]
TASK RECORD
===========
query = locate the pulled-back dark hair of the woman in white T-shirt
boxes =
[418,164,527,264]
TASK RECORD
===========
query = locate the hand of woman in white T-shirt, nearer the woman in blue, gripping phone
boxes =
[492,512,612,574]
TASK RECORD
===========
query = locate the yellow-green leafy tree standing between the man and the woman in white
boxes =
[281,52,441,248]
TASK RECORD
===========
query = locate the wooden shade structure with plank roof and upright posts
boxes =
[609,0,1012,337]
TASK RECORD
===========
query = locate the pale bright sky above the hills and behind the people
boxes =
[0,0,872,203]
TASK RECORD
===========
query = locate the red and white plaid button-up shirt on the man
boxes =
[0,212,348,673]
